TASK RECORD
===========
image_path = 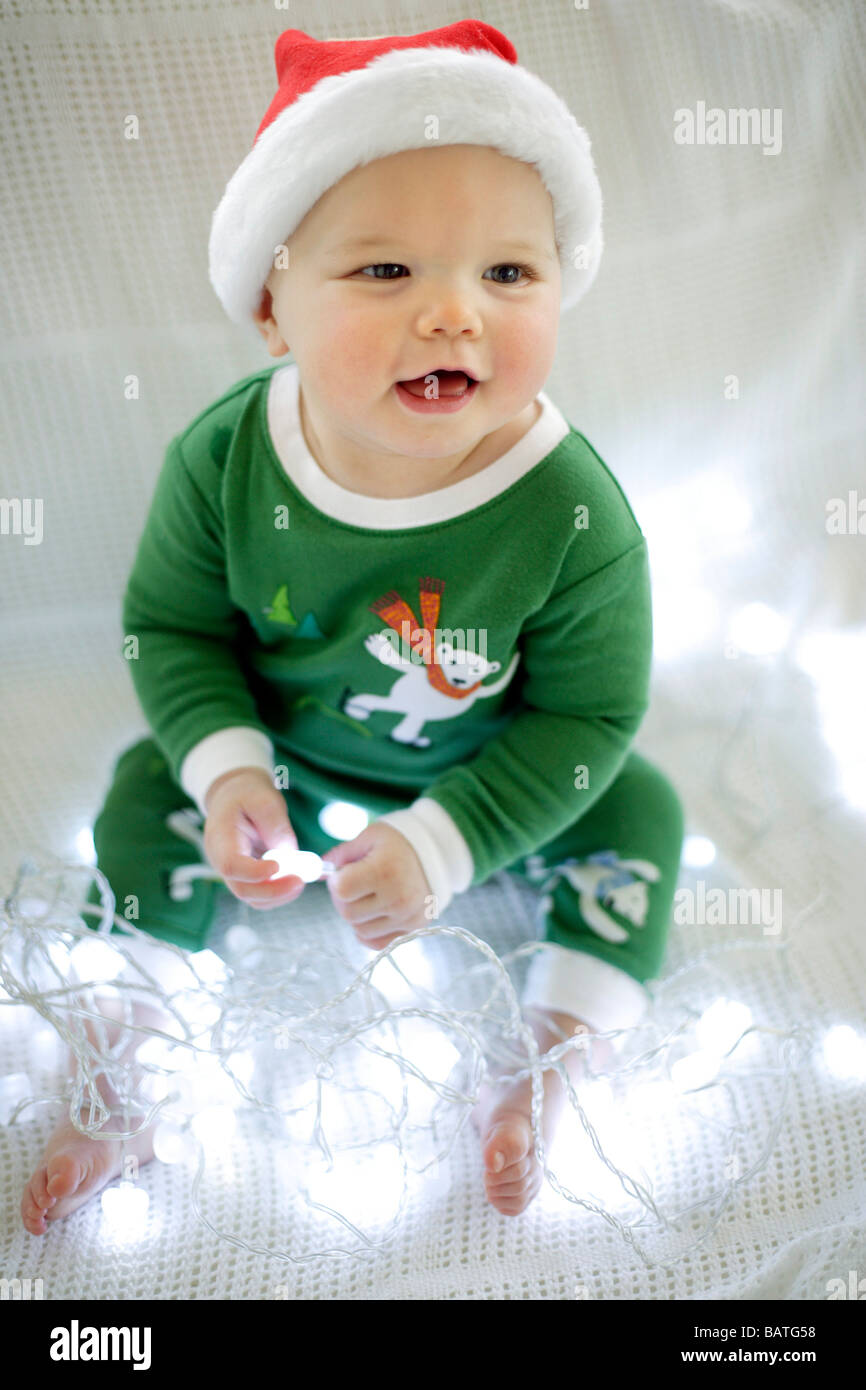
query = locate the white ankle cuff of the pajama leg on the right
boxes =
[521,941,649,1033]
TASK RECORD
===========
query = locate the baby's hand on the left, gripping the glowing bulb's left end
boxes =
[204,767,304,909]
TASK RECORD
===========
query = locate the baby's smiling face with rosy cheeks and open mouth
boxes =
[260,145,562,459]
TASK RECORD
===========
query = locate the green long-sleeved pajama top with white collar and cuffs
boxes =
[122,363,652,917]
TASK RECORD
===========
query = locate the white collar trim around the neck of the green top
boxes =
[267,363,571,531]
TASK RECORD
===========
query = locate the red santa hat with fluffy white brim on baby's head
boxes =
[210,19,603,327]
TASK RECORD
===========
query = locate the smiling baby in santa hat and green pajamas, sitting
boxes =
[21,19,683,1234]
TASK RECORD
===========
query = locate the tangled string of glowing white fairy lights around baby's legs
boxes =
[0,839,866,1268]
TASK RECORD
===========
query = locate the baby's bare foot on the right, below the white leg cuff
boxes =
[473,1011,607,1216]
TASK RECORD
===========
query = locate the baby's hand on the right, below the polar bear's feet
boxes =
[322,820,431,951]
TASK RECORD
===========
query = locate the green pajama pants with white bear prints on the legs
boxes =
[88,738,684,1017]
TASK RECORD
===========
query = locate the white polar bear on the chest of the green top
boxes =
[342,632,520,748]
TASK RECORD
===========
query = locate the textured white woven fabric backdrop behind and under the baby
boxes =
[0,0,866,1300]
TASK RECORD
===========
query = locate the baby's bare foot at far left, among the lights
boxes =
[21,1001,167,1236]
